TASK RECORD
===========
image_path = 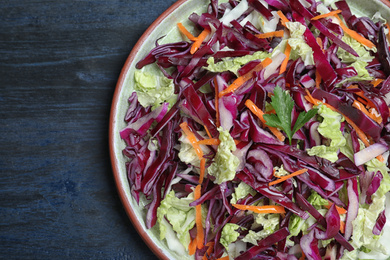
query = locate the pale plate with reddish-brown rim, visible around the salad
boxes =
[109,0,390,259]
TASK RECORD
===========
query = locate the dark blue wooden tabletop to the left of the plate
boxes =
[0,0,175,259]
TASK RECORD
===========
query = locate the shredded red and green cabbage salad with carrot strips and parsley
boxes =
[120,0,390,260]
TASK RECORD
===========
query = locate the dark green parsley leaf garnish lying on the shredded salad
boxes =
[264,86,318,144]
